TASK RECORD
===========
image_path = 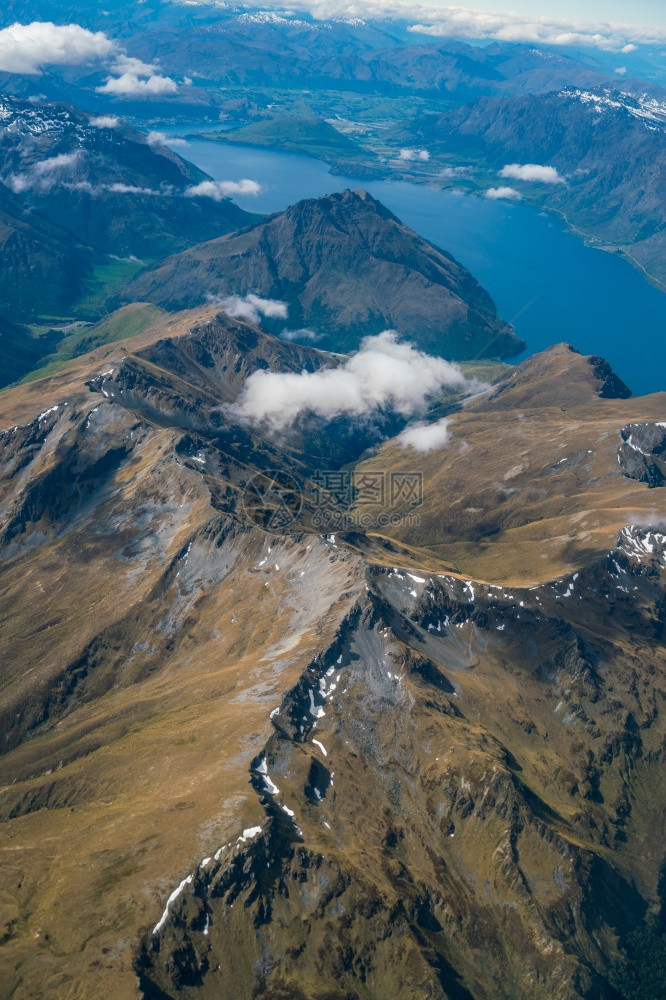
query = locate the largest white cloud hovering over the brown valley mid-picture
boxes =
[230,330,471,430]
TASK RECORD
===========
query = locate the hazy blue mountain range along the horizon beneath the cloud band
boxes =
[126,9,624,104]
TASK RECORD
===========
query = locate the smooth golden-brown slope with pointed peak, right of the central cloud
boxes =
[350,345,664,585]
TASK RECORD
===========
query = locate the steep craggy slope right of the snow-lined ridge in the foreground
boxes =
[138,531,666,1000]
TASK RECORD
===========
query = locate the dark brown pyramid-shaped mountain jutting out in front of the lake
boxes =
[120,190,522,359]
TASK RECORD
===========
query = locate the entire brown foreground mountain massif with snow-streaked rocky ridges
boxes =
[0,310,666,1000]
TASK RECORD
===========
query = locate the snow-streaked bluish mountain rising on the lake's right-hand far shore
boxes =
[407,88,666,286]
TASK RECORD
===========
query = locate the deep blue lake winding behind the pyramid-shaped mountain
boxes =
[172,141,666,393]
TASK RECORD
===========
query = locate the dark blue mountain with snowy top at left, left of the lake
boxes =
[0,95,252,318]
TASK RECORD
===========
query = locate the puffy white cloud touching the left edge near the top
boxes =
[0,21,115,74]
